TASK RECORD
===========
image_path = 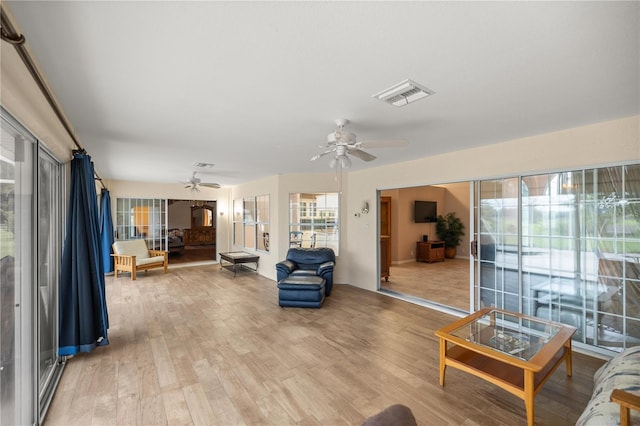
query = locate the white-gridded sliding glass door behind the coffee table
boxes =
[474,164,640,351]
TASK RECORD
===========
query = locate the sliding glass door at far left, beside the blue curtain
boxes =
[0,109,64,425]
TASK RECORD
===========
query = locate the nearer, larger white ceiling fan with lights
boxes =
[311,118,408,168]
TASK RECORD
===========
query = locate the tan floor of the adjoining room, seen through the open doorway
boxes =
[380,259,469,312]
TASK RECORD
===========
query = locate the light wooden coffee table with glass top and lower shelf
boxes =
[436,308,576,426]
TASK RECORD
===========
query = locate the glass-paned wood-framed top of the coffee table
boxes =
[450,310,562,361]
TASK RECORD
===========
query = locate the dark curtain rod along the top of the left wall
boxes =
[0,8,107,189]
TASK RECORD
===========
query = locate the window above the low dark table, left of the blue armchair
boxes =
[233,195,270,251]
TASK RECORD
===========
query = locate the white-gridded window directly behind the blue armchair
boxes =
[289,192,340,255]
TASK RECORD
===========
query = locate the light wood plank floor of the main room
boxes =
[45,265,603,426]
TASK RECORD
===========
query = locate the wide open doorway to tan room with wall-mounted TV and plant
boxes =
[378,182,472,312]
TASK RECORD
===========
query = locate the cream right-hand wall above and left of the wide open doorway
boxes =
[342,116,640,290]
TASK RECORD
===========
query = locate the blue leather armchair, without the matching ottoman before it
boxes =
[276,247,336,296]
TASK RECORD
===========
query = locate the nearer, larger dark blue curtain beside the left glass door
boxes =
[58,152,109,356]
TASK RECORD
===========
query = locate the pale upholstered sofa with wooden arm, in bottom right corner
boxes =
[576,346,640,426]
